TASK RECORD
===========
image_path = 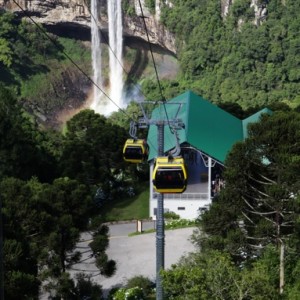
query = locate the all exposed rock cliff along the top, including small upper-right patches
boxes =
[0,0,267,54]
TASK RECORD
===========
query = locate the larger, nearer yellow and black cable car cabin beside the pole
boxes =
[152,157,187,193]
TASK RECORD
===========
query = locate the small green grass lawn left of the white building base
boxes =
[102,182,149,222]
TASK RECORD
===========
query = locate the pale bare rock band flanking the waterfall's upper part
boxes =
[0,0,176,54]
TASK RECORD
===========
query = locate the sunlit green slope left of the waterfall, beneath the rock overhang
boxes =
[0,11,90,127]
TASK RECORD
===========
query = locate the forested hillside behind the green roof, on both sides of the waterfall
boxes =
[0,0,300,127]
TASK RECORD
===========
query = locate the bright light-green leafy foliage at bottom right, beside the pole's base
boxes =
[162,249,279,300]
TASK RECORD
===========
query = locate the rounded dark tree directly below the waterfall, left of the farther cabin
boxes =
[61,110,126,185]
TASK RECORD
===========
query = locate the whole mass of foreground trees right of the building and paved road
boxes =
[163,111,300,300]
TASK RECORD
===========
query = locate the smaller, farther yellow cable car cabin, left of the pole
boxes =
[123,139,148,163]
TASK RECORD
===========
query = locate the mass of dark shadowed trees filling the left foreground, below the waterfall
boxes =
[0,84,146,299]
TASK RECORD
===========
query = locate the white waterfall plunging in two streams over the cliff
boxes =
[91,0,124,115]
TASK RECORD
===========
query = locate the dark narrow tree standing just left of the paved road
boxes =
[40,178,92,278]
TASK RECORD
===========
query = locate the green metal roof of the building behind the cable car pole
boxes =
[147,91,269,163]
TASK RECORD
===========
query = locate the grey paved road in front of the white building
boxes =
[74,222,195,294]
